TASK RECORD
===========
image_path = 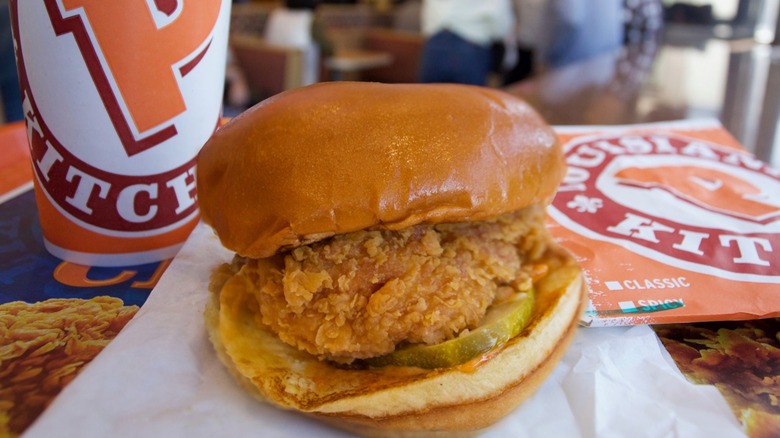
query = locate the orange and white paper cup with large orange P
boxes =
[10,0,231,266]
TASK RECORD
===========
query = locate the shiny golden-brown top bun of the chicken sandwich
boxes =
[197,82,565,258]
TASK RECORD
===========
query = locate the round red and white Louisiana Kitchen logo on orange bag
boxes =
[550,134,780,283]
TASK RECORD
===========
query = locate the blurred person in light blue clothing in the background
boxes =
[538,0,623,69]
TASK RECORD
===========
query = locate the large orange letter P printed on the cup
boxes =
[62,0,221,132]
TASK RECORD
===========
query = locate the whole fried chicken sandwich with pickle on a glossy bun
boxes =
[198,82,584,436]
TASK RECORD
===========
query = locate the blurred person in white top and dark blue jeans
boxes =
[420,0,514,85]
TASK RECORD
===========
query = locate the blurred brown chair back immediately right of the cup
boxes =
[230,35,303,101]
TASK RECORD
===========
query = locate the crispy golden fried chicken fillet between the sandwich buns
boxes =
[239,207,546,362]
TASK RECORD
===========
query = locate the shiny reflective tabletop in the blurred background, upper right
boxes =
[507,39,780,167]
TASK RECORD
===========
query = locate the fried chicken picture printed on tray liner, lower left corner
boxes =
[0,297,138,437]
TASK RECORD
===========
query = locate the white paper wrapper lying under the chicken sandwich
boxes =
[25,224,744,438]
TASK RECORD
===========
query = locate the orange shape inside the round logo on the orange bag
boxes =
[615,166,780,219]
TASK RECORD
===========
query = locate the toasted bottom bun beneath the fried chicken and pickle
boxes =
[205,248,585,437]
